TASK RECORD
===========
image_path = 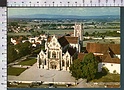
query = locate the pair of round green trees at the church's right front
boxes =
[70,53,98,82]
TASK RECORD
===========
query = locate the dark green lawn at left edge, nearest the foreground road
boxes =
[7,67,26,76]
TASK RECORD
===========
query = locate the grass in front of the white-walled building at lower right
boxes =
[92,73,120,82]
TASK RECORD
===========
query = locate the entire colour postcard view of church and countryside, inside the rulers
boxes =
[7,7,121,88]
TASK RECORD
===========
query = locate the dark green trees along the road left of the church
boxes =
[7,42,32,63]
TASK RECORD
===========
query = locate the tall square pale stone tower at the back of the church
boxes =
[74,23,83,41]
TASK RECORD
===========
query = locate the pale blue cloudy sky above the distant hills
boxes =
[8,7,120,17]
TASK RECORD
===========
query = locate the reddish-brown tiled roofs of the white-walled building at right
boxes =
[78,43,120,64]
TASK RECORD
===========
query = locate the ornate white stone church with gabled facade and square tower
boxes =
[37,24,83,71]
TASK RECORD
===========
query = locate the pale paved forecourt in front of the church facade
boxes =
[8,63,75,83]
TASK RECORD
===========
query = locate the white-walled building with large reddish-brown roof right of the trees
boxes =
[86,43,120,74]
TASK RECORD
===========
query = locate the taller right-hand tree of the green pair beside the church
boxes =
[82,53,98,81]
